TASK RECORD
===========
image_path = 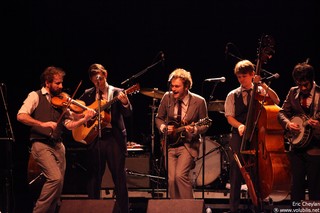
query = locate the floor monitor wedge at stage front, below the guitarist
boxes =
[59,199,115,213]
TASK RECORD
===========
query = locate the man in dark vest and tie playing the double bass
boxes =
[224,60,280,212]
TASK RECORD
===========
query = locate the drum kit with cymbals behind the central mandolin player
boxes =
[140,88,231,186]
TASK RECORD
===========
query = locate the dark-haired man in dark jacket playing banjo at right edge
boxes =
[278,62,320,203]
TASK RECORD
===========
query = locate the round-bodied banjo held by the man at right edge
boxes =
[286,112,320,148]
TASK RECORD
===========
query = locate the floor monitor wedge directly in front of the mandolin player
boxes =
[147,199,205,213]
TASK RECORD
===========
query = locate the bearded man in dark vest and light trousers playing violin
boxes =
[17,66,95,213]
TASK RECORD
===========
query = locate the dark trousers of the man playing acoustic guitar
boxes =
[87,132,129,213]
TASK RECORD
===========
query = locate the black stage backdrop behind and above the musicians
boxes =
[0,0,320,212]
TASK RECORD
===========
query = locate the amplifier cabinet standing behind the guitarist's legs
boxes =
[101,154,150,188]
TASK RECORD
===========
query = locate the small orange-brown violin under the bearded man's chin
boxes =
[51,92,87,113]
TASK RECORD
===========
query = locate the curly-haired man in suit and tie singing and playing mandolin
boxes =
[155,68,211,199]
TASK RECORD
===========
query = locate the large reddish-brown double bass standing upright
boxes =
[240,35,291,207]
